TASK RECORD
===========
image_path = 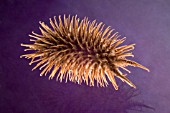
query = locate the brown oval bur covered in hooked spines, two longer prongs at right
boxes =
[21,15,149,90]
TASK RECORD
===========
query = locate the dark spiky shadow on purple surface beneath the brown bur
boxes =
[38,83,154,113]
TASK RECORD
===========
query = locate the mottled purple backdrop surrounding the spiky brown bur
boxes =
[0,0,170,113]
